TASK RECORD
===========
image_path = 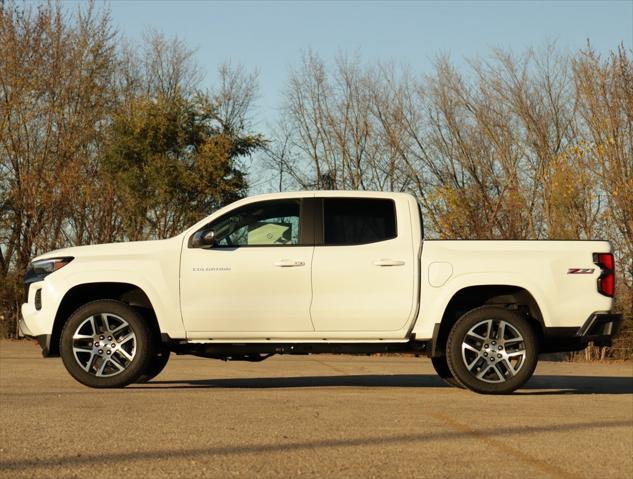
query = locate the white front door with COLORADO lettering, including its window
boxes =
[181,199,314,338]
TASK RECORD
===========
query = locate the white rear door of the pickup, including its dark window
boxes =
[310,197,415,337]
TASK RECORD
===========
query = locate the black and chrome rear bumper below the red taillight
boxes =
[541,312,622,353]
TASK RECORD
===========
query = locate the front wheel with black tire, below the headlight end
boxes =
[59,299,156,388]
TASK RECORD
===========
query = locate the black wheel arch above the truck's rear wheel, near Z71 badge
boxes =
[430,284,545,357]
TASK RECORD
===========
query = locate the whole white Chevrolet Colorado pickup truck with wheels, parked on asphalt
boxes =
[20,191,621,394]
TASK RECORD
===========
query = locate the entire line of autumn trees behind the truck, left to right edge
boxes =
[0,4,633,354]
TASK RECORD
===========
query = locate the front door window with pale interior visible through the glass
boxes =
[211,200,300,247]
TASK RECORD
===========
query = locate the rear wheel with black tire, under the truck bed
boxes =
[446,306,538,394]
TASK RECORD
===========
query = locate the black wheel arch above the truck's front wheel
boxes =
[50,282,160,356]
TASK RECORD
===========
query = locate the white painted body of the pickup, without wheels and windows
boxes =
[21,191,617,394]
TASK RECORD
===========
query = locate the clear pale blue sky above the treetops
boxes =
[101,0,633,129]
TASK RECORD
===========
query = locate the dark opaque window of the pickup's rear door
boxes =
[323,198,396,245]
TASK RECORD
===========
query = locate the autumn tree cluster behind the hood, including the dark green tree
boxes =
[0,3,264,334]
